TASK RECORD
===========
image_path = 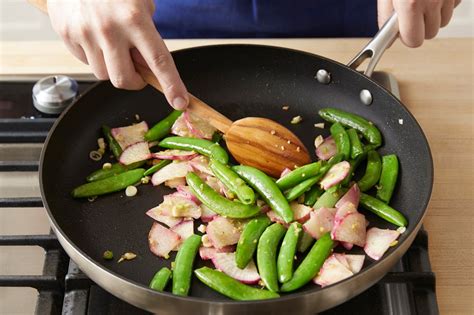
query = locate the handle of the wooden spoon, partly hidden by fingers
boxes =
[135,63,232,134]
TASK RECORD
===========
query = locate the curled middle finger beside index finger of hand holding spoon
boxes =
[103,46,146,90]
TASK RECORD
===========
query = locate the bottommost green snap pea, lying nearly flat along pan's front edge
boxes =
[194,267,279,301]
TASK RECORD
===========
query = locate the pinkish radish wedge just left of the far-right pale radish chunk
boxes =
[331,213,366,247]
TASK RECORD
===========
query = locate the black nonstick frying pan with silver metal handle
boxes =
[40,16,433,314]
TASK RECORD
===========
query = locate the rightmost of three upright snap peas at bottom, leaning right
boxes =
[281,233,334,292]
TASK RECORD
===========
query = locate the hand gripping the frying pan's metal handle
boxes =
[377,0,461,47]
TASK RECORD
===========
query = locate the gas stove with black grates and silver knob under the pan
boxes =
[0,72,438,315]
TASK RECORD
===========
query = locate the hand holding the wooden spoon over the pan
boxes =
[48,0,189,109]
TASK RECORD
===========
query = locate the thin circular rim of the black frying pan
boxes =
[39,43,434,306]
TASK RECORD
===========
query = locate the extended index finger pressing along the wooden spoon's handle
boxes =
[134,23,189,110]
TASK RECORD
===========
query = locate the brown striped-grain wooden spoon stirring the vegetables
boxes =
[135,63,311,177]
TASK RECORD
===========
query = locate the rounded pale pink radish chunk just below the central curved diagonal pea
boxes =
[206,216,241,248]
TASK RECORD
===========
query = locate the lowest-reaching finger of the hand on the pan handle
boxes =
[394,1,425,47]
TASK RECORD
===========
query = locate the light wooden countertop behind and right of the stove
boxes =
[0,39,474,314]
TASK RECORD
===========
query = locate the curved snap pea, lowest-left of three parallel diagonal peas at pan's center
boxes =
[186,173,260,219]
